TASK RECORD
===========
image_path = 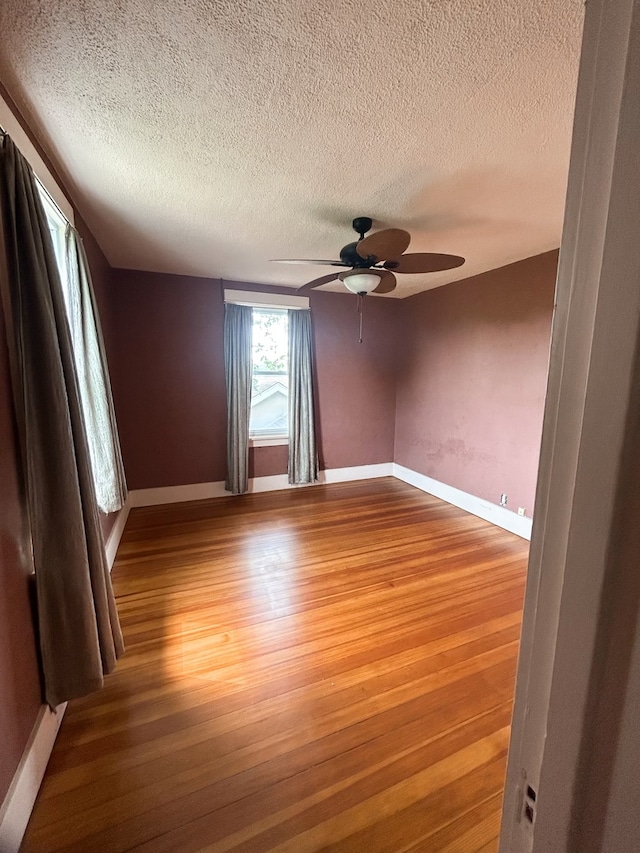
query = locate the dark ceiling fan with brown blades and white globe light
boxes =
[274,216,464,296]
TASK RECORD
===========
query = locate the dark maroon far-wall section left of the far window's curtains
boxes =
[110,270,226,489]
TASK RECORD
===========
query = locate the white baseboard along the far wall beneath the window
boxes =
[129,462,393,507]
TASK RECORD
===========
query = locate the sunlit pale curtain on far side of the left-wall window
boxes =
[65,224,127,513]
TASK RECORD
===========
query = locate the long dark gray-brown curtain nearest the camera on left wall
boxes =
[0,136,123,707]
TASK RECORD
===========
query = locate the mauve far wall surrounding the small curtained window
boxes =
[110,270,400,489]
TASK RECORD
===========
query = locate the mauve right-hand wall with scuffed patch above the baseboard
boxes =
[395,246,557,515]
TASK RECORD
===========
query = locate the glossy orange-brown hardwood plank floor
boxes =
[22,478,528,853]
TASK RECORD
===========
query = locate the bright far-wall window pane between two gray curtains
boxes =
[249,307,289,438]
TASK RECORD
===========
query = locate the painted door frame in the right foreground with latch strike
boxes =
[500,0,640,853]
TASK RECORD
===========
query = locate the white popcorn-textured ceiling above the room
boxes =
[0,0,583,296]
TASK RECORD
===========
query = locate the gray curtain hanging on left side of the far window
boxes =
[224,303,253,495]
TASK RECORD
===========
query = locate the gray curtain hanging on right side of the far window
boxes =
[289,310,318,484]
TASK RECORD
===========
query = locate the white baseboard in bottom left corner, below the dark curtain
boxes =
[0,702,67,853]
